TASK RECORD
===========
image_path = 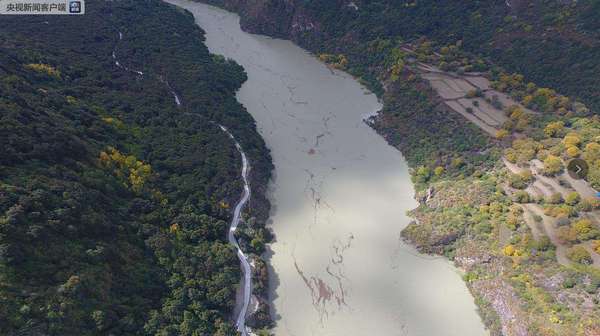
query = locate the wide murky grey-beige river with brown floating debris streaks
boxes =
[163,0,487,336]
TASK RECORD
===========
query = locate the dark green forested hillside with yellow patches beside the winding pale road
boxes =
[0,0,271,335]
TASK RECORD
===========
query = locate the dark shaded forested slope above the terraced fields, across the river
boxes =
[205,0,600,112]
